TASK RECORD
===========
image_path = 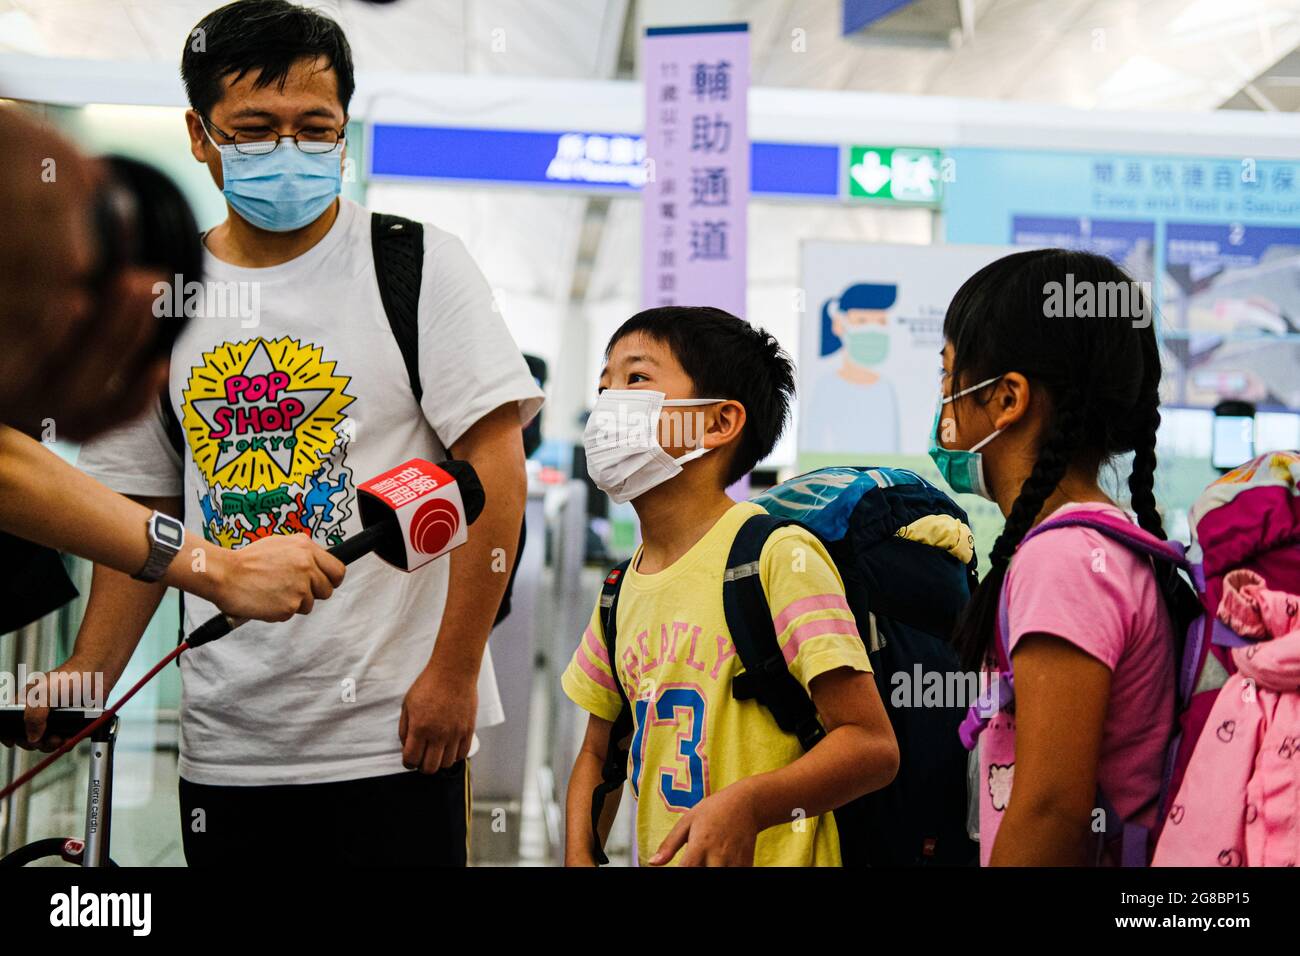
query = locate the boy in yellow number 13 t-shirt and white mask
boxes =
[563,307,898,866]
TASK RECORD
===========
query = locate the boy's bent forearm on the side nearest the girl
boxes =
[733,724,898,830]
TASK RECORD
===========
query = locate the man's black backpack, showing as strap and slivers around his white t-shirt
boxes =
[160,212,522,628]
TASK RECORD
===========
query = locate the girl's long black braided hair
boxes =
[944,248,1165,669]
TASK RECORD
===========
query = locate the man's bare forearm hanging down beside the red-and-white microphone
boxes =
[432,434,527,675]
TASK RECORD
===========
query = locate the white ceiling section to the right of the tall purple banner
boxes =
[733,0,1300,109]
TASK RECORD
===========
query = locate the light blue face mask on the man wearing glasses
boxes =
[208,134,343,233]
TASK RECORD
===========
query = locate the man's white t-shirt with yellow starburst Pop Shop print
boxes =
[78,199,542,786]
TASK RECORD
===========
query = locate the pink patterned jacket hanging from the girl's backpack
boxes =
[1153,570,1300,866]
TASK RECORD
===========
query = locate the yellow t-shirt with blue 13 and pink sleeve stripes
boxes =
[562,502,871,866]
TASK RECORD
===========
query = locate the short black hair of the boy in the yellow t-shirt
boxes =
[605,306,794,484]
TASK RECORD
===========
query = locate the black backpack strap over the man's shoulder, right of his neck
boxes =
[371,212,424,402]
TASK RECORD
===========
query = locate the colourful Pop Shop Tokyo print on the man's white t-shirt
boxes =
[181,337,356,548]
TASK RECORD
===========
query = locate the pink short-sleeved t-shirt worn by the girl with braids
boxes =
[979,503,1174,866]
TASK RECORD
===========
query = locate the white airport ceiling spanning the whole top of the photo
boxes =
[0,0,1300,109]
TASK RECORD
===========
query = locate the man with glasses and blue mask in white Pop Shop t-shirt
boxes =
[69,0,542,865]
